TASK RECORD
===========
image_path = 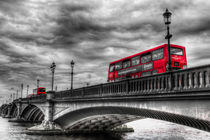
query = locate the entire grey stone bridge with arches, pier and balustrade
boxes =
[0,65,210,131]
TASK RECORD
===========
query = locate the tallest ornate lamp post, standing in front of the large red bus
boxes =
[163,9,172,71]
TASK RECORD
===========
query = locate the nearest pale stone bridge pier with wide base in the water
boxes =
[28,91,62,134]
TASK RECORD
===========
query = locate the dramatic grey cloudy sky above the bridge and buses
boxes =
[0,0,210,103]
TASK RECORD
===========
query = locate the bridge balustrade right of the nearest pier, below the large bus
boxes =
[55,65,210,98]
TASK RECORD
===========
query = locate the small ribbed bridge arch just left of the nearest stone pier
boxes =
[20,104,44,122]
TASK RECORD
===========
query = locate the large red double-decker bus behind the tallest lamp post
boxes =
[108,44,187,82]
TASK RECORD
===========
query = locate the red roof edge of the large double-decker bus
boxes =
[110,44,185,64]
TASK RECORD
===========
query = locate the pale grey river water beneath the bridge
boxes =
[0,117,210,140]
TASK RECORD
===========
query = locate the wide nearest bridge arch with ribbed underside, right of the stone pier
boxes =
[54,106,210,131]
